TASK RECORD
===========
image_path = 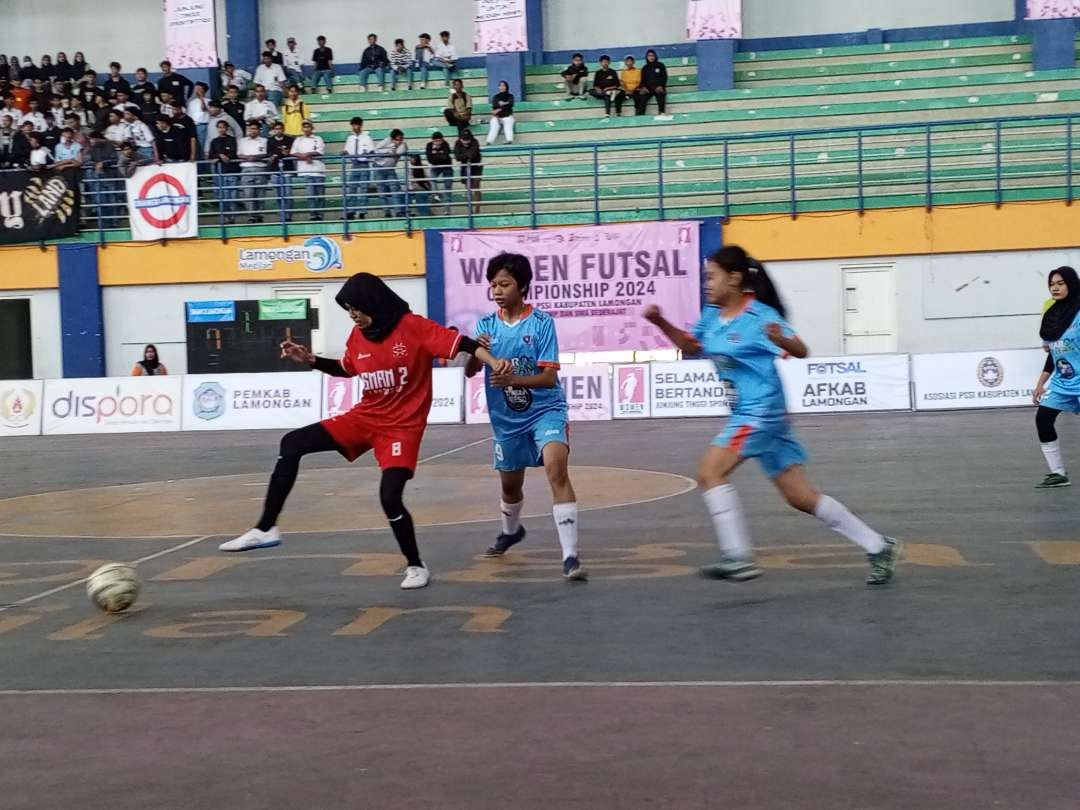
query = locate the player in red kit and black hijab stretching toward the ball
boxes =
[219,273,511,590]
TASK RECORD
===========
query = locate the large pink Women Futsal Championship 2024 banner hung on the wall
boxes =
[443,221,701,352]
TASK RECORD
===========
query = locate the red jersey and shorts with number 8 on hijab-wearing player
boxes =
[323,312,461,469]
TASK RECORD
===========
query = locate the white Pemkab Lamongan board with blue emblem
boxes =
[184,372,323,430]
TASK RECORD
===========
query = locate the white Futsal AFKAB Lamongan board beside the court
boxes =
[777,354,912,414]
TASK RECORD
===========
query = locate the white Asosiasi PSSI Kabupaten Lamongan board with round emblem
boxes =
[912,349,1047,410]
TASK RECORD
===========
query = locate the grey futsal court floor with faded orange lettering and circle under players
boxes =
[0,409,1080,810]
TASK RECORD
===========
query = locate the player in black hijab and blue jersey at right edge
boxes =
[1031,267,1080,489]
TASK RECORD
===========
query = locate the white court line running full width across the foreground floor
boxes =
[0,678,1080,698]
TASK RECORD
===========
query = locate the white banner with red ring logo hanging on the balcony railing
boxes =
[125,163,199,242]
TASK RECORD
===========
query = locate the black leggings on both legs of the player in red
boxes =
[255,422,423,565]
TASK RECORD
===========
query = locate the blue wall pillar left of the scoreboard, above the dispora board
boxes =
[56,244,105,377]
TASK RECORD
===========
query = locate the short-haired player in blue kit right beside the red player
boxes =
[465,253,589,581]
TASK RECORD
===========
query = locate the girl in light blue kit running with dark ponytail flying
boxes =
[645,245,900,585]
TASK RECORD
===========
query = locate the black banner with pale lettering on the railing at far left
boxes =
[0,168,79,244]
